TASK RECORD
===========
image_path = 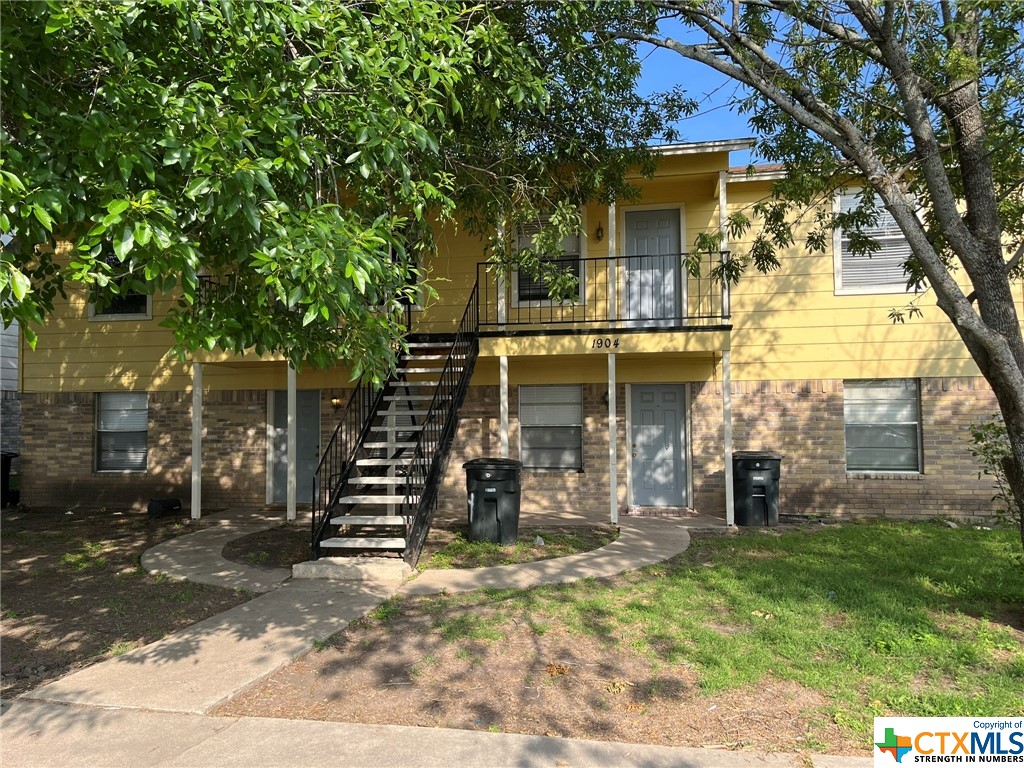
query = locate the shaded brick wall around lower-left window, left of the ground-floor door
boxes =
[22,390,266,507]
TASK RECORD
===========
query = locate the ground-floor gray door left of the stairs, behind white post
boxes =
[270,389,319,504]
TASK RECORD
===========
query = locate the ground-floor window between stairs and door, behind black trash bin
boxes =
[519,384,583,470]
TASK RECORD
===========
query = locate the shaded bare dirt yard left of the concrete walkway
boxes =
[0,508,252,698]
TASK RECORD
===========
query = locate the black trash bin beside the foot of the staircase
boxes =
[462,459,522,547]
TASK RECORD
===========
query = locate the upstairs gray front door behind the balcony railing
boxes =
[626,208,682,325]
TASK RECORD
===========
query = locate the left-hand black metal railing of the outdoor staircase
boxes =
[311,383,384,560]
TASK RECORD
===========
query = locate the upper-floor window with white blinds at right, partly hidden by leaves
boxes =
[834,189,910,294]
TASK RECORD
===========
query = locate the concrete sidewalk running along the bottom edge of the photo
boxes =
[0,699,871,768]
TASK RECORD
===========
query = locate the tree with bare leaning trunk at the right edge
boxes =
[594,0,1024,544]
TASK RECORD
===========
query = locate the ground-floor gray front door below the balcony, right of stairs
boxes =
[630,384,687,507]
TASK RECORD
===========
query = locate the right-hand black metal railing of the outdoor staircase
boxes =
[401,285,479,567]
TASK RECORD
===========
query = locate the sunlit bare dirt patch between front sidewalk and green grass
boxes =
[217,601,867,755]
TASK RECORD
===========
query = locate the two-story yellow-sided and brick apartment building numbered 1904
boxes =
[20,140,996,561]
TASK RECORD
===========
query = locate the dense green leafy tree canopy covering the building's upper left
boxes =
[0,0,681,379]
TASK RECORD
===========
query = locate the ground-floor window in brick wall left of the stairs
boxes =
[96,392,150,472]
